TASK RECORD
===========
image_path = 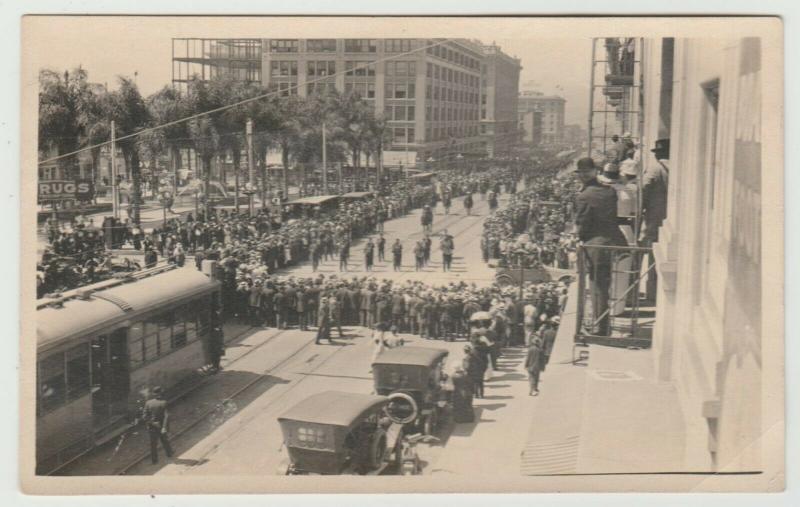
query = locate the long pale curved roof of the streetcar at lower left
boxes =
[36,267,219,349]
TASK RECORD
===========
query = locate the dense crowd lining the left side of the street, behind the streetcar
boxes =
[37,163,516,297]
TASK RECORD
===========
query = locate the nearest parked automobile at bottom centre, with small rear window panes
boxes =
[278,391,419,475]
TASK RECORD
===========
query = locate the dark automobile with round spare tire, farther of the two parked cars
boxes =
[372,347,452,435]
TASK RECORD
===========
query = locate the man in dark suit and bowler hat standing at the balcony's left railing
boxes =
[575,157,627,336]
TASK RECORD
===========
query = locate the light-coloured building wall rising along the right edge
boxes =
[643,39,762,470]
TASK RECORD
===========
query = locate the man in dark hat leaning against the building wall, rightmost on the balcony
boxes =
[640,139,669,300]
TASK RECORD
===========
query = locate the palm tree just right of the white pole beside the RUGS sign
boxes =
[109,76,149,224]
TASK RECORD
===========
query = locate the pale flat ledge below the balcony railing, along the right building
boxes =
[520,284,685,475]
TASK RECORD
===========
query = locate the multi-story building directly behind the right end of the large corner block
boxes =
[481,44,522,156]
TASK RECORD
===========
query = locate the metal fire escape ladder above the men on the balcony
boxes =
[588,37,644,161]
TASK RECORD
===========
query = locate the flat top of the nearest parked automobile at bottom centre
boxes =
[278,391,389,427]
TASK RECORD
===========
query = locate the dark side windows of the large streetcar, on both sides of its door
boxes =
[37,300,211,415]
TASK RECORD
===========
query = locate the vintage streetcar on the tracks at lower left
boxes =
[36,266,220,474]
